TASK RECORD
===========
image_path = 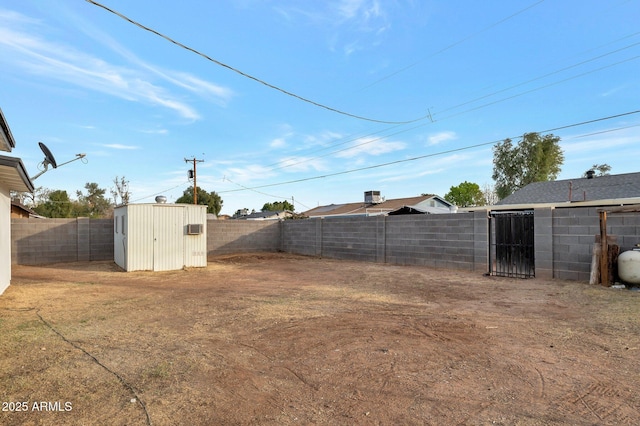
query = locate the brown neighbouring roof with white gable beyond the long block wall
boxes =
[304,195,452,218]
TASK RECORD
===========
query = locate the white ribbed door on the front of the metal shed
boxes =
[153,207,184,271]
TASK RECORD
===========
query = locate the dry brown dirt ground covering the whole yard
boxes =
[0,254,640,425]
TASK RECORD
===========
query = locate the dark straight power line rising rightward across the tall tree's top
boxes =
[220,110,640,193]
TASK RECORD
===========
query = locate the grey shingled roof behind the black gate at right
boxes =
[496,173,640,205]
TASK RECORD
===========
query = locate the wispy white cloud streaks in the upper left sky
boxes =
[0,11,232,120]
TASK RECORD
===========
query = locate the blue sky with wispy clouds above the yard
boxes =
[0,0,640,214]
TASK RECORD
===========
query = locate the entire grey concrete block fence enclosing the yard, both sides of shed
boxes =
[11,207,640,281]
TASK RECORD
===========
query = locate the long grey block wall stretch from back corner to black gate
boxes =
[282,212,488,272]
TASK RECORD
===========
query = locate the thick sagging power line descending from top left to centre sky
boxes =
[85,0,429,124]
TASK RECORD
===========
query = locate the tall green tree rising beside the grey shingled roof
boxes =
[492,133,564,199]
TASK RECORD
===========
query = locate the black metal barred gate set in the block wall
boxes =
[489,210,536,278]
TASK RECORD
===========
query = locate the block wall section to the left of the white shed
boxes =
[11,218,113,265]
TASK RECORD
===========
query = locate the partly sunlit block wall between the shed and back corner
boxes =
[207,220,281,256]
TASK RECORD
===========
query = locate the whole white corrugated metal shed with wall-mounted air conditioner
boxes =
[113,203,207,271]
